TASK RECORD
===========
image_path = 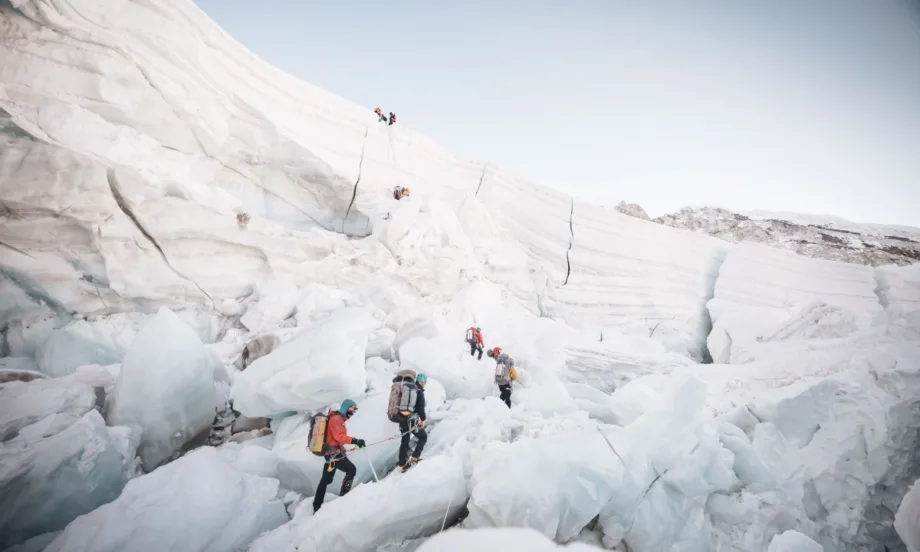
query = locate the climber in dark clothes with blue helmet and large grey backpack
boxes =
[387,370,428,471]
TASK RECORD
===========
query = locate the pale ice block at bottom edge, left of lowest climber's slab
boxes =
[45,448,288,552]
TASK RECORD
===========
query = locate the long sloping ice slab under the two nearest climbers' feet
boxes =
[250,456,467,552]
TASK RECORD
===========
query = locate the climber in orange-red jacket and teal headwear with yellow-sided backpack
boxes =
[309,399,365,513]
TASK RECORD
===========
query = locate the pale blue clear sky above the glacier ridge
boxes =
[196,0,920,226]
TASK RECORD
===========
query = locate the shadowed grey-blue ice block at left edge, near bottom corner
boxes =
[0,410,126,548]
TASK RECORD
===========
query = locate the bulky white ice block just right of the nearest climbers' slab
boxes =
[465,431,620,542]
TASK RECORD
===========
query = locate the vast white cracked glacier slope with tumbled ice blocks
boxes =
[0,0,920,552]
